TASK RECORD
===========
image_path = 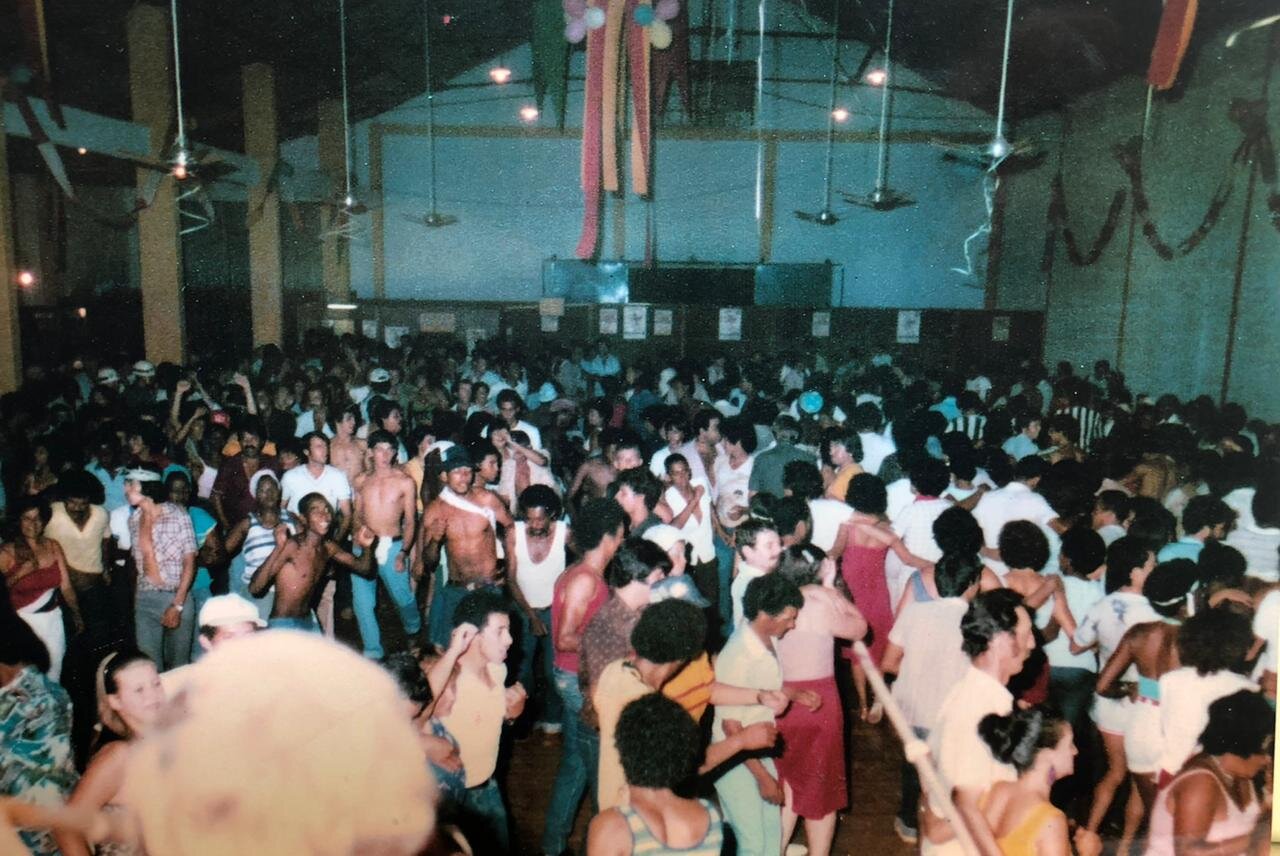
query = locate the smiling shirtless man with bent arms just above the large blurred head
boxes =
[248,494,375,633]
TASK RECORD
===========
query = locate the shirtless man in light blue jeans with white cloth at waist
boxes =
[351,431,422,660]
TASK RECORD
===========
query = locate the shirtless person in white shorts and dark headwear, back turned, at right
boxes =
[1097,559,1197,852]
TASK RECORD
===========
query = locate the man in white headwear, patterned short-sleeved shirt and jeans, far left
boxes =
[124,468,196,670]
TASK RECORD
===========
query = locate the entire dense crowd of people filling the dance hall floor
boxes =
[0,324,1280,856]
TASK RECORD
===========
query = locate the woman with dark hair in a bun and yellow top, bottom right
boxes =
[978,708,1075,856]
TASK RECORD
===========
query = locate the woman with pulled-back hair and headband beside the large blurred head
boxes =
[55,650,165,856]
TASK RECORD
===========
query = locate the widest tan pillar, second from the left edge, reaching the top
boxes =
[125,4,187,363]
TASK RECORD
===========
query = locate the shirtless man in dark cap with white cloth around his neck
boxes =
[413,445,513,647]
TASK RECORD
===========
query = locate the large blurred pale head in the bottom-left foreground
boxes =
[124,631,435,856]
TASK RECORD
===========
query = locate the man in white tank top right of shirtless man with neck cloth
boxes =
[506,485,568,734]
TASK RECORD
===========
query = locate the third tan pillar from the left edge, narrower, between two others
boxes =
[241,63,284,347]
